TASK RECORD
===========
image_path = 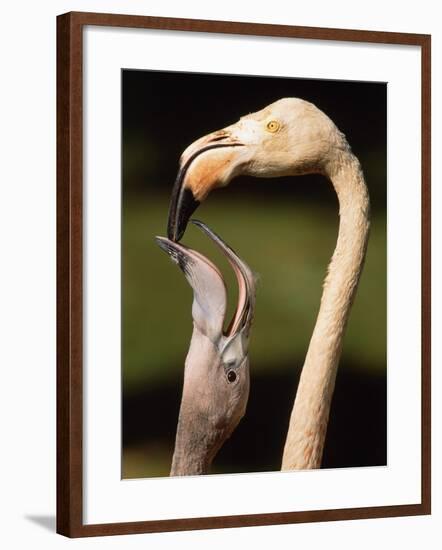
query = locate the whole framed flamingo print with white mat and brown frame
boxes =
[57,12,431,537]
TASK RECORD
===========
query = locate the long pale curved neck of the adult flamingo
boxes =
[282,150,370,470]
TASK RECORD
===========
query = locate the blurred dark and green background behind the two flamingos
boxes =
[122,70,387,478]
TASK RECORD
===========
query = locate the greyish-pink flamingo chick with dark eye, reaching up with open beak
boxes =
[156,221,255,476]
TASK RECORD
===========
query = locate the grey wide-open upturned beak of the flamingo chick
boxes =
[156,220,256,339]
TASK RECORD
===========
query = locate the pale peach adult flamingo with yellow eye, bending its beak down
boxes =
[168,98,370,470]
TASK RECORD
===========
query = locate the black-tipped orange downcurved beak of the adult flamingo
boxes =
[167,129,242,242]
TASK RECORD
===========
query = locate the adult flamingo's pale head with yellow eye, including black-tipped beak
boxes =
[167,98,347,241]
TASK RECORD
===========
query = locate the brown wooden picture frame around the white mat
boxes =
[57,12,431,537]
